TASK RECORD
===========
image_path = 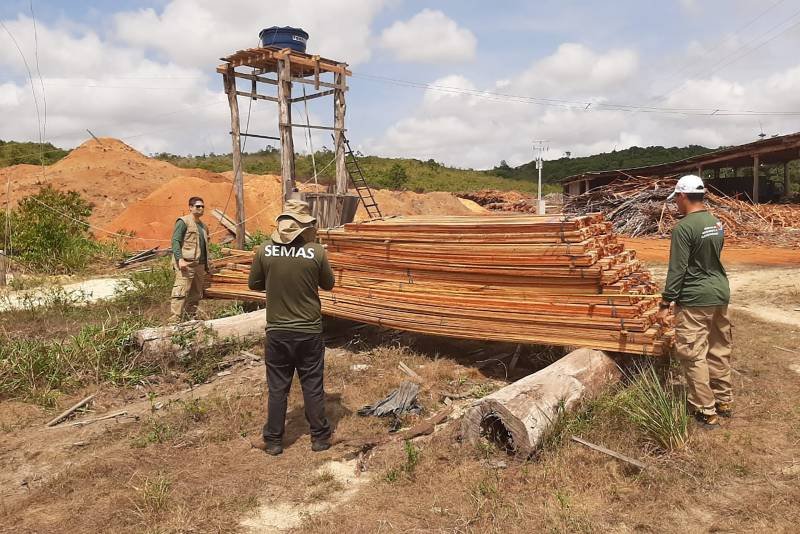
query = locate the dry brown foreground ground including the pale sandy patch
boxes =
[0,266,800,533]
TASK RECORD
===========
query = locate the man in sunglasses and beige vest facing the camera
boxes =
[169,197,208,324]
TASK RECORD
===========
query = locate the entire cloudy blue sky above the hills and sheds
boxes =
[0,0,800,168]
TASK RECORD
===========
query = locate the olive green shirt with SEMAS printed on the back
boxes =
[247,237,334,334]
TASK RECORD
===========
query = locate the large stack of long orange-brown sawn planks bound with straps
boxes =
[206,214,671,354]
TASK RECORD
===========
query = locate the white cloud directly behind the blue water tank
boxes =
[115,0,385,68]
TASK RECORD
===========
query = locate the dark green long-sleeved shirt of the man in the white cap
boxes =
[662,210,731,306]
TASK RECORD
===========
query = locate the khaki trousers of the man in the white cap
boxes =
[675,305,733,415]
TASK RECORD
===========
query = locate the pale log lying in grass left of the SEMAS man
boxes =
[132,310,267,357]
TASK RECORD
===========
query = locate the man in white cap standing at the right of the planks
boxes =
[659,174,733,430]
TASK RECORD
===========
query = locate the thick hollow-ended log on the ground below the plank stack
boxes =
[461,348,622,456]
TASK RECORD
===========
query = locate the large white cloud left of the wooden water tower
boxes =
[0,16,245,152]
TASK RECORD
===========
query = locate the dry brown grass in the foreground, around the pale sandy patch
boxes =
[0,314,800,533]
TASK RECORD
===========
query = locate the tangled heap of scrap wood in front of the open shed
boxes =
[564,177,800,246]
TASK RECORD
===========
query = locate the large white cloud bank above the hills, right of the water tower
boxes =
[366,44,800,174]
